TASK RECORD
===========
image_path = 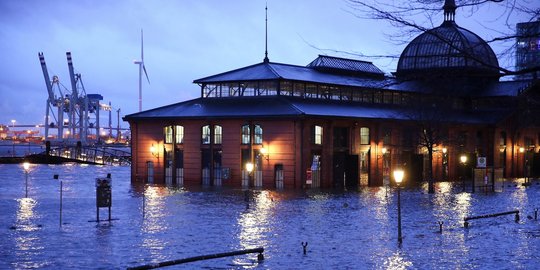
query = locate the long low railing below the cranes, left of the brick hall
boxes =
[44,146,131,165]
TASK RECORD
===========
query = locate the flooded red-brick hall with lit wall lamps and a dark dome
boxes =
[124,1,540,188]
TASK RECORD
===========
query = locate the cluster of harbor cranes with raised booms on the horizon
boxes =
[38,52,111,144]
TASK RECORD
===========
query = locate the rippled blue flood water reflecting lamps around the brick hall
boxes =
[0,164,540,269]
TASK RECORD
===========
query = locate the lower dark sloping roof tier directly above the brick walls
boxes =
[124,96,508,124]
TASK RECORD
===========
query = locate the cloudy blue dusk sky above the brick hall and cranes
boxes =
[0,0,540,127]
